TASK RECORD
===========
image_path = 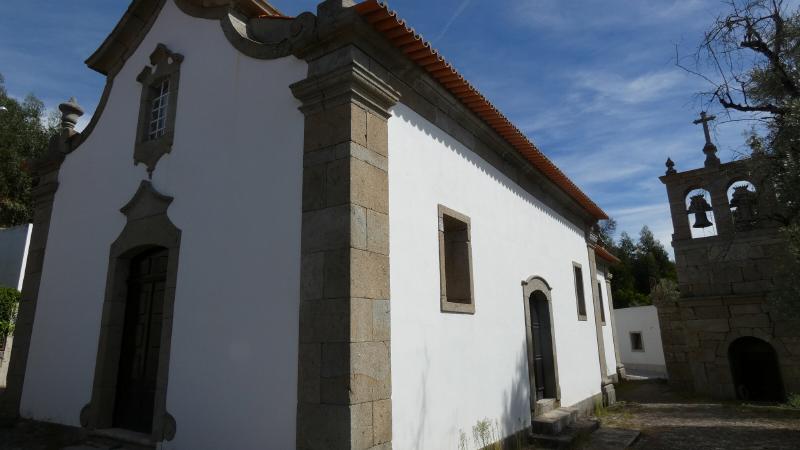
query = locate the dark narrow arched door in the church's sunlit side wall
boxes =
[529,293,555,400]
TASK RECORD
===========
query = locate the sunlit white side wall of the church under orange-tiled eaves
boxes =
[389,105,600,450]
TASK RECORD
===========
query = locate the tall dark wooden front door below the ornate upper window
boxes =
[114,249,167,433]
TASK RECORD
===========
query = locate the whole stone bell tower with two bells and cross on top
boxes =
[655,113,800,400]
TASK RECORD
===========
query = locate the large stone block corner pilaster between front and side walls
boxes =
[292,54,398,450]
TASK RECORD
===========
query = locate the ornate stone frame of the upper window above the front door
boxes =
[133,44,183,176]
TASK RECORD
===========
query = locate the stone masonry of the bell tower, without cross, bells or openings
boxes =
[656,155,800,398]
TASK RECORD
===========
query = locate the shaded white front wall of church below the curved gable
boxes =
[22,1,306,449]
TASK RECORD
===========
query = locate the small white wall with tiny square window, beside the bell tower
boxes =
[614,306,667,377]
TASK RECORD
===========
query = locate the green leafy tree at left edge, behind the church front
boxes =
[0,75,55,227]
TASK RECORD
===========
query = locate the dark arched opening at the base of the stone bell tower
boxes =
[728,336,785,402]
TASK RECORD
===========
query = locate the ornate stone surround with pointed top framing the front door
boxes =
[80,181,181,442]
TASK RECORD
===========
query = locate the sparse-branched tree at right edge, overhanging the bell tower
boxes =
[692,0,800,312]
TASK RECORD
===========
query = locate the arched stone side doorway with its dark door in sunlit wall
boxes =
[522,276,561,415]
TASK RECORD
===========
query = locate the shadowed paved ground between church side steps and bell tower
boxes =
[601,381,800,450]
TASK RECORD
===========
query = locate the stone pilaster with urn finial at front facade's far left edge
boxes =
[0,99,83,420]
